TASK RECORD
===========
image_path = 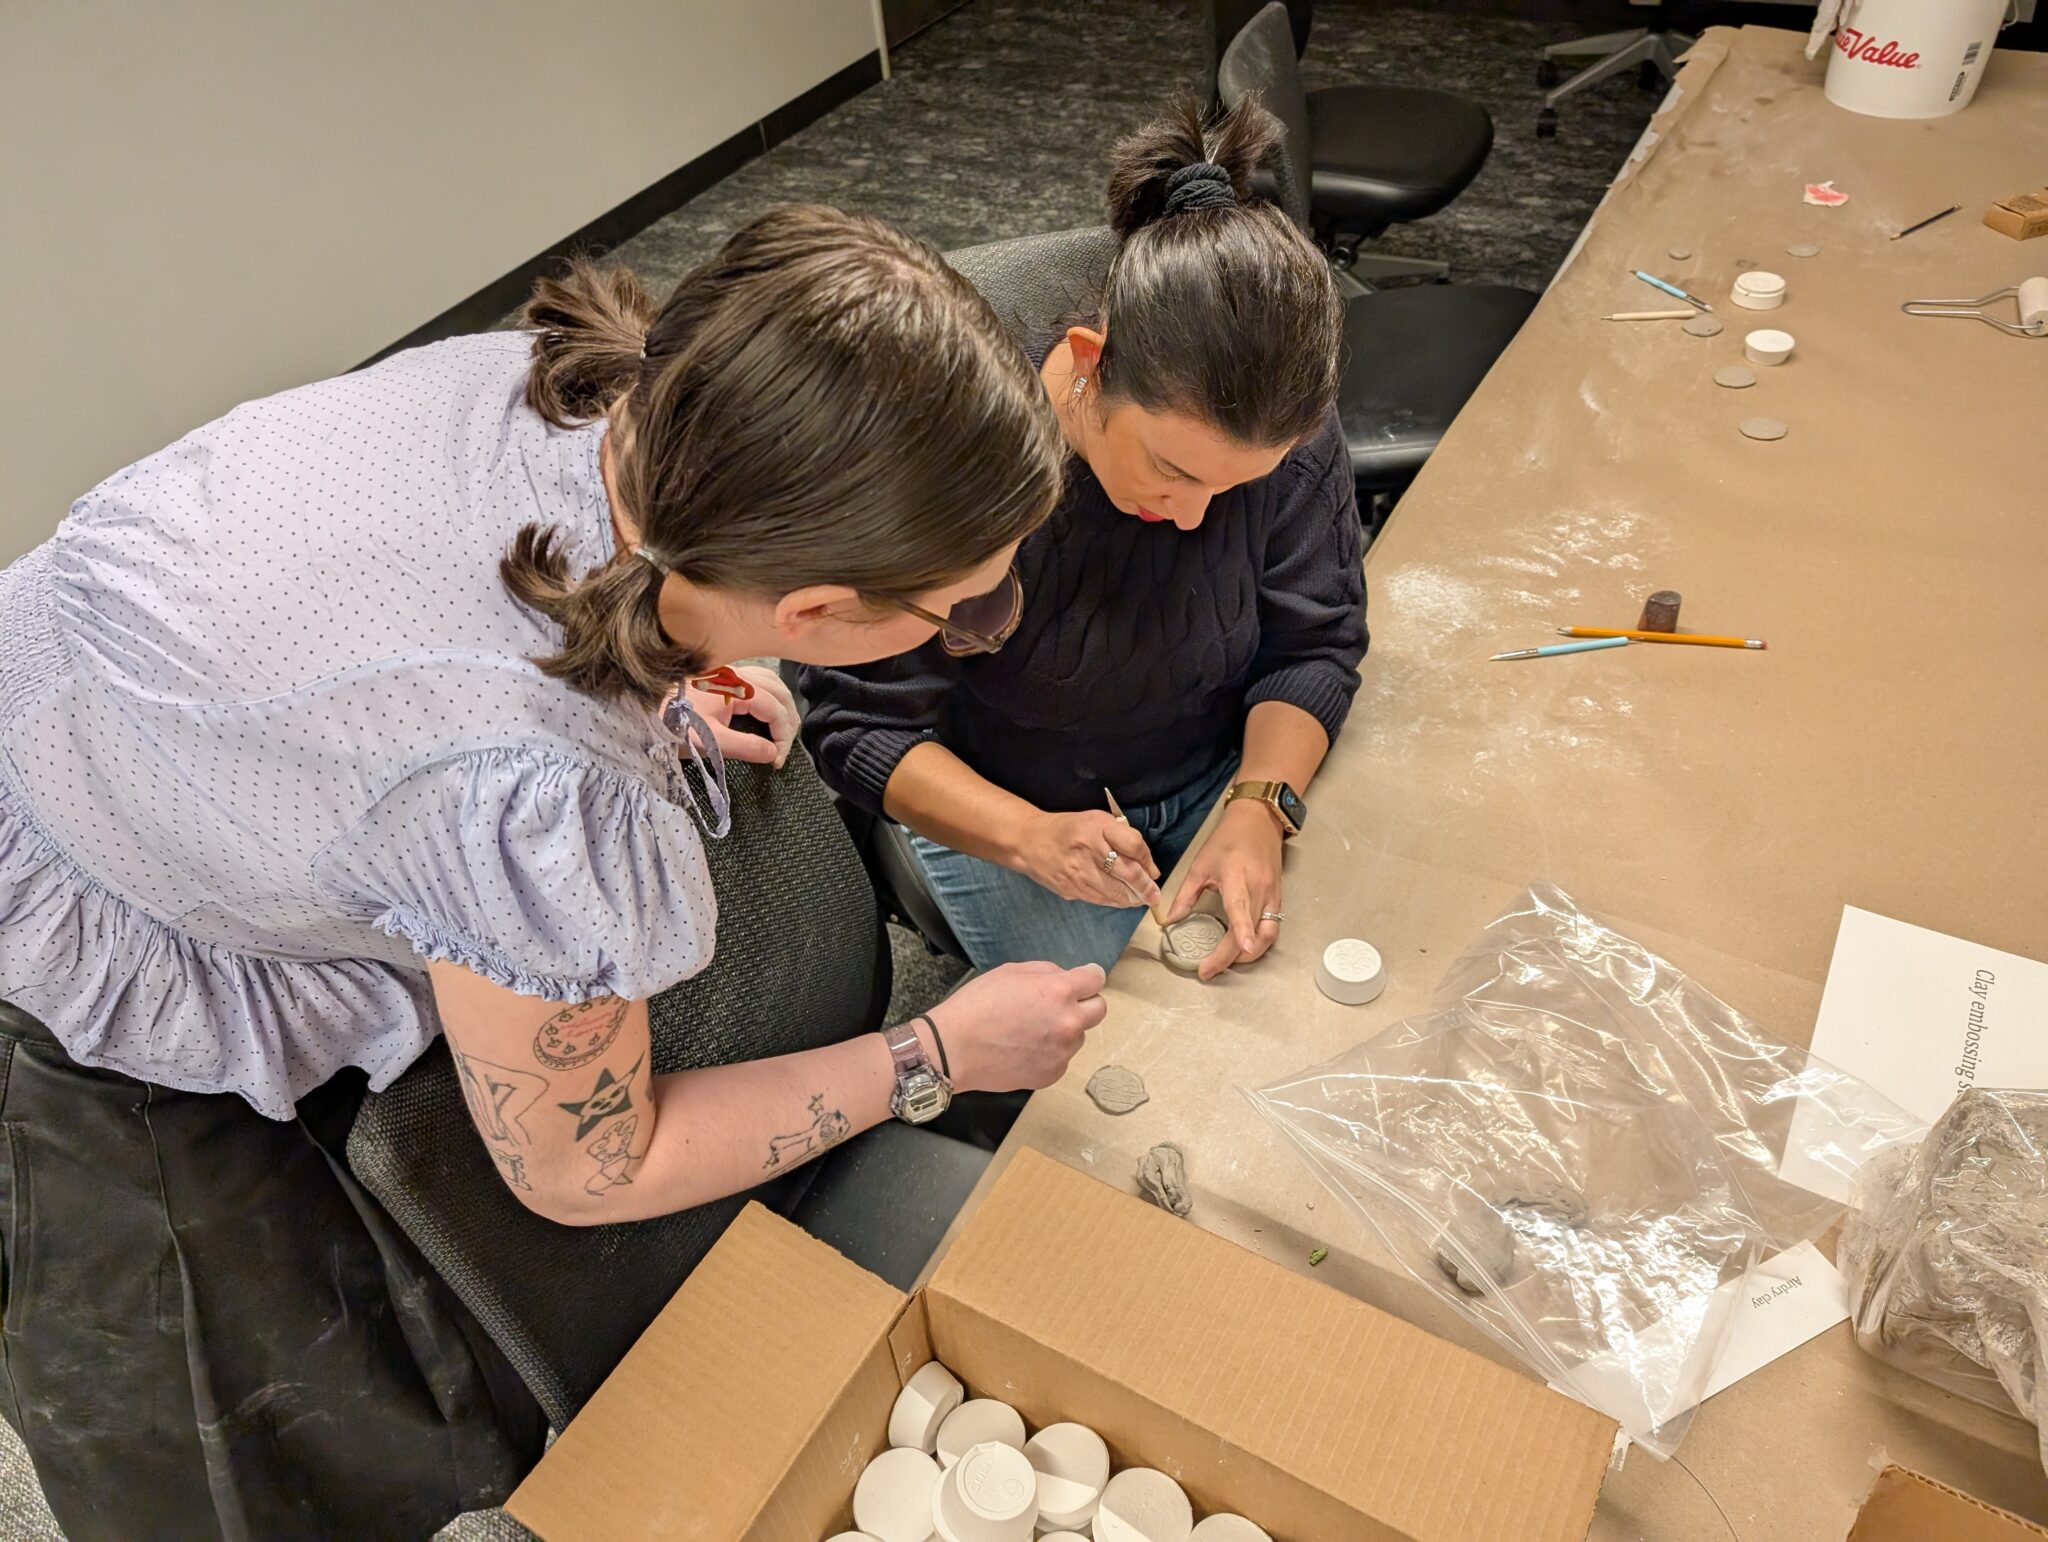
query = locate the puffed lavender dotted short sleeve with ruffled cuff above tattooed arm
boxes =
[317,749,719,1001]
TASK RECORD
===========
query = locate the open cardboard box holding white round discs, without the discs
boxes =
[506,1151,1614,1542]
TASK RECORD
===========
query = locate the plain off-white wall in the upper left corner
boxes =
[0,0,877,563]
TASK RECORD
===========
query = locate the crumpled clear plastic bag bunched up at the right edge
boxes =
[1839,1087,2048,1468]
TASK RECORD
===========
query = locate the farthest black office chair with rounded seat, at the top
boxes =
[1204,0,1493,283]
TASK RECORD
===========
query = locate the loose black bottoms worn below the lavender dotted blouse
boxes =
[0,1001,545,1542]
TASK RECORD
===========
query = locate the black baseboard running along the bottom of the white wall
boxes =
[356,51,883,369]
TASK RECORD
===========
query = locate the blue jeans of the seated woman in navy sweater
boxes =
[909,756,1237,969]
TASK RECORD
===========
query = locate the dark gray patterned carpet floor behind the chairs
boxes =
[0,0,1657,1542]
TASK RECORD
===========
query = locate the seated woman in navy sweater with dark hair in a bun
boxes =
[799,104,1366,979]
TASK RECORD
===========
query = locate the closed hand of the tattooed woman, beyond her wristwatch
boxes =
[932,962,1108,1091]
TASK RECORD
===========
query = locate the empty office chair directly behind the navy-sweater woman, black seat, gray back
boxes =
[1217,0,1536,511]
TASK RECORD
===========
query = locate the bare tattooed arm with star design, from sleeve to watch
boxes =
[428,962,901,1227]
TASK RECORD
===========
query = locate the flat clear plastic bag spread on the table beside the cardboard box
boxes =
[1247,885,1925,1456]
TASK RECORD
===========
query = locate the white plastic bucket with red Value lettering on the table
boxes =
[1827,0,2007,119]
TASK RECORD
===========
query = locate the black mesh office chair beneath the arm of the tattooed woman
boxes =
[348,749,991,1429]
